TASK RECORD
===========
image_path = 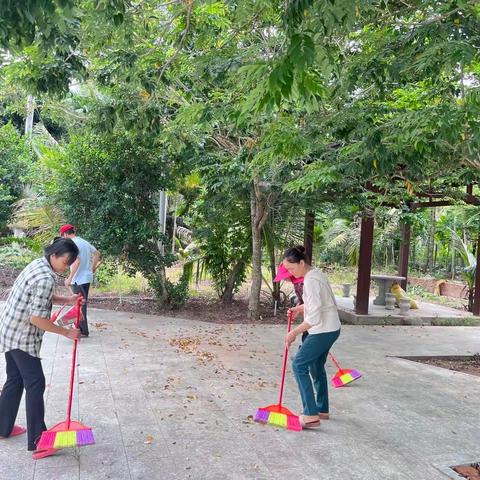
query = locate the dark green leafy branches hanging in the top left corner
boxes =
[0,0,129,95]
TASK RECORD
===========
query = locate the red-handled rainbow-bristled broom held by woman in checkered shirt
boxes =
[37,297,95,450]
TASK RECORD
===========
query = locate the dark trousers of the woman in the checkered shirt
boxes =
[0,349,47,450]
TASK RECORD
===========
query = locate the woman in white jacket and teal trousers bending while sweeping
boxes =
[283,247,340,428]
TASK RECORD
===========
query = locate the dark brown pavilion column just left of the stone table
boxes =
[355,211,373,315]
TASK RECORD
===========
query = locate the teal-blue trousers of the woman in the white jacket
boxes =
[292,329,340,415]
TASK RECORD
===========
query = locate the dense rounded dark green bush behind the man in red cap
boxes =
[47,132,176,296]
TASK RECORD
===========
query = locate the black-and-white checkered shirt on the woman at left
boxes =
[0,257,55,357]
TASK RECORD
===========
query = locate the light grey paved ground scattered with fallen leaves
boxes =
[0,310,480,480]
